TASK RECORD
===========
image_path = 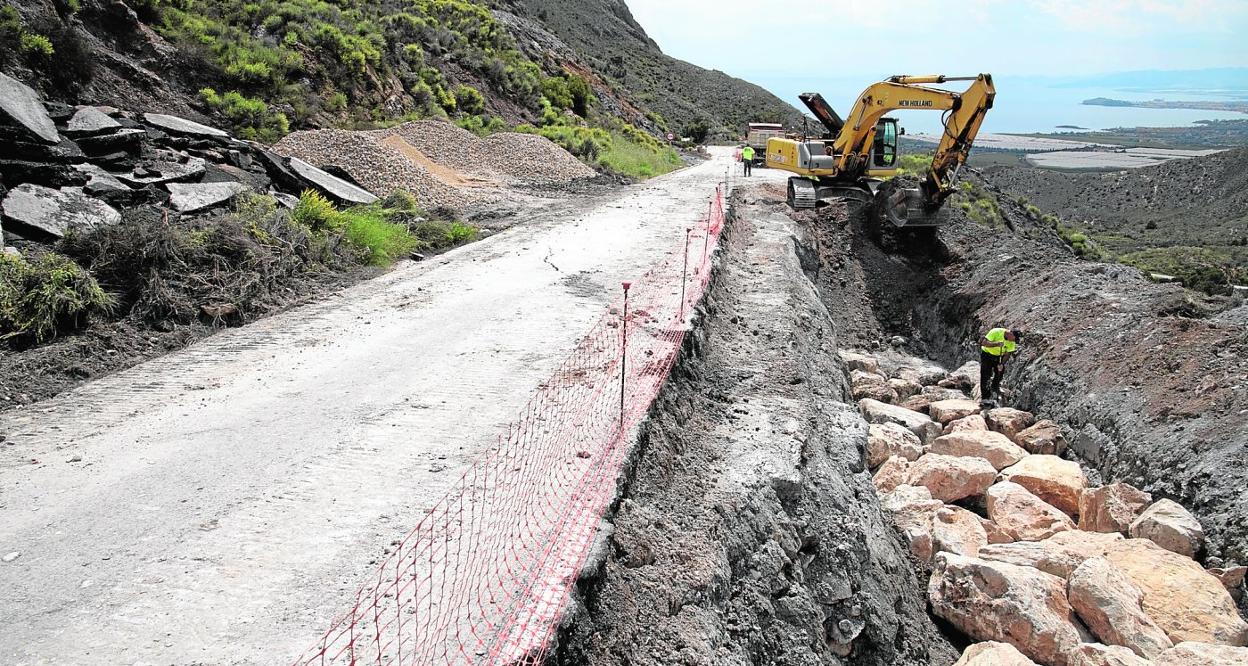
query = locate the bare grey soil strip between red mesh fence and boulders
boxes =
[552,206,956,666]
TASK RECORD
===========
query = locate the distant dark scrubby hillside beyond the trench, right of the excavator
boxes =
[986,148,1248,292]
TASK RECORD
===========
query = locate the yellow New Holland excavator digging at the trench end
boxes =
[766,74,996,228]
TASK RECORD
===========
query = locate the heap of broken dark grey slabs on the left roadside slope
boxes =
[0,74,377,253]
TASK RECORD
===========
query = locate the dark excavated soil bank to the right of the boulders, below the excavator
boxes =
[799,174,1248,564]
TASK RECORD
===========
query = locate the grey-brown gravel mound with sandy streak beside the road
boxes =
[273,121,597,208]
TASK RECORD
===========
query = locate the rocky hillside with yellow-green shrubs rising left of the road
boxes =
[0,0,797,142]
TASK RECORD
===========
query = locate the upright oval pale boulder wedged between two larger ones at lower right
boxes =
[1067,557,1174,659]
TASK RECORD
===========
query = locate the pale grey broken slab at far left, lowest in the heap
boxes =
[0,183,121,241]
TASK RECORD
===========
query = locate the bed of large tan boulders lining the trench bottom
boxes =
[841,352,1248,666]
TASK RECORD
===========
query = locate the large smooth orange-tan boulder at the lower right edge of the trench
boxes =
[1106,539,1248,646]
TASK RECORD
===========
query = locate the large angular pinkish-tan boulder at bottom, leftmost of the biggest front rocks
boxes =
[927,553,1085,666]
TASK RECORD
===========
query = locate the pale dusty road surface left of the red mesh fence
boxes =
[0,152,758,664]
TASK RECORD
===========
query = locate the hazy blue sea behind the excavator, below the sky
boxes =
[755,76,1248,133]
